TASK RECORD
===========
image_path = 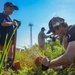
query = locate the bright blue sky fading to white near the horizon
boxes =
[0,0,75,47]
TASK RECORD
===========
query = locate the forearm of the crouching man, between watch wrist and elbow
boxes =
[49,54,71,68]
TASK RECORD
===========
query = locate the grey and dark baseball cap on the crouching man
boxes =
[47,17,64,34]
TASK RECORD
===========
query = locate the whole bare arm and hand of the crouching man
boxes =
[41,41,75,68]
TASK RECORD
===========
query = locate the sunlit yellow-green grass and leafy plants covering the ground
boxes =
[1,40,75,75]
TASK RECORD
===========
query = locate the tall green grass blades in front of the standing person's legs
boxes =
[0,25,19,74]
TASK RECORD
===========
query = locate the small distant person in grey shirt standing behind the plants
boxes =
[38,27,50,50]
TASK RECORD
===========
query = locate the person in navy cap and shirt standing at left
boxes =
[0,2,21,69]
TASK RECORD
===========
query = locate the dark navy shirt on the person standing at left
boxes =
[0,13,13,45]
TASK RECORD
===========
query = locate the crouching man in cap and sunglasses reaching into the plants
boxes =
[39,17,75,68]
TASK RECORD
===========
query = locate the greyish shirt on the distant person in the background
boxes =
[38,31,50,46]
